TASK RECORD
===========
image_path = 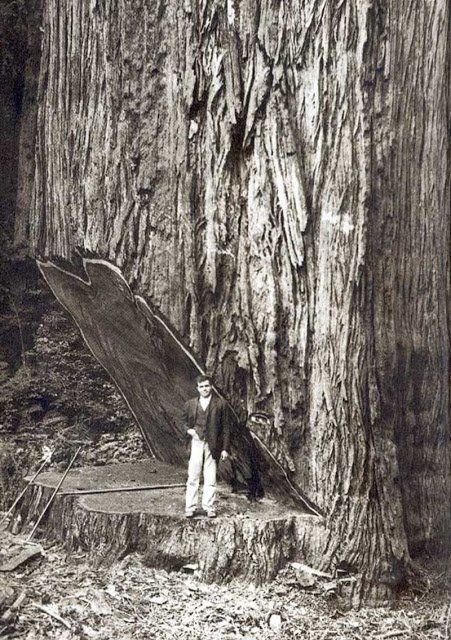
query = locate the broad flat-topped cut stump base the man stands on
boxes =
[11,460,326,585]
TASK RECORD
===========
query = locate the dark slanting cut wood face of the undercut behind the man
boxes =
[38,259,320,515]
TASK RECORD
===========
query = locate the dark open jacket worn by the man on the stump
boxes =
[182,395,231,462]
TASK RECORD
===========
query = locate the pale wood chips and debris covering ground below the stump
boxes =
[0,531,451,640]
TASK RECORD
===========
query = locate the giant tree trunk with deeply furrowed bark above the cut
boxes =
[12,0,449,597]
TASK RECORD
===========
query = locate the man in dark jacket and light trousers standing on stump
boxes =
[182,376,230,518]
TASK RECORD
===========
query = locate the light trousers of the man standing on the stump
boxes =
[185,437,216,514]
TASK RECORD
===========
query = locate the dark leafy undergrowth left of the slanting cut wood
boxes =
[0,284,143,508]
